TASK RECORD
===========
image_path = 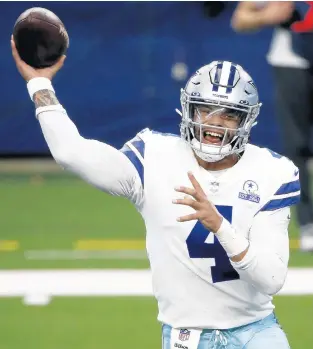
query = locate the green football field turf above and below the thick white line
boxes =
[0,174,313,349]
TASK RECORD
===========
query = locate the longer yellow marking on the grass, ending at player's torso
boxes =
[73,240,146,251]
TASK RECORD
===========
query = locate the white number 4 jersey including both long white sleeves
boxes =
[38,107,300,329]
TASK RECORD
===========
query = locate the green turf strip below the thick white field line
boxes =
[0,296,313,349]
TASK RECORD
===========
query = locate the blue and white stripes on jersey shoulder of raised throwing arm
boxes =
[120,140,145,186]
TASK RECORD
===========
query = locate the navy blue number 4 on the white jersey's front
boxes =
[186,206,239,283]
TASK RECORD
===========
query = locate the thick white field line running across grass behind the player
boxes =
[0,268,313,304]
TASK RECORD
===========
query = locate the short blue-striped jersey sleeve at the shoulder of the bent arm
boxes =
[259,158,301,212]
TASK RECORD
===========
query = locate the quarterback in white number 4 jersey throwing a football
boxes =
[11,36,300,349]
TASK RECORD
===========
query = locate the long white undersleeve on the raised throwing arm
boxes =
[38,109,143,209]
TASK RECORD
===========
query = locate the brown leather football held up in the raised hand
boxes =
[13,7,69,68]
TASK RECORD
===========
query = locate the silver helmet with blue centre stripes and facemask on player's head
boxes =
[180,62,261,162]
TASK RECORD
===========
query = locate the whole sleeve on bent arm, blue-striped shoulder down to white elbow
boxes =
[225,156,300,295]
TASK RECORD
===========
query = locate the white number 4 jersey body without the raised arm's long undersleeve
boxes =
[121,129,300,329]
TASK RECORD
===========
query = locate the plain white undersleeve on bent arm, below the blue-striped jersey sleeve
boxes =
[231,207,290,295]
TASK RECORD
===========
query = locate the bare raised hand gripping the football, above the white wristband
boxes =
[11,35,66,82]
